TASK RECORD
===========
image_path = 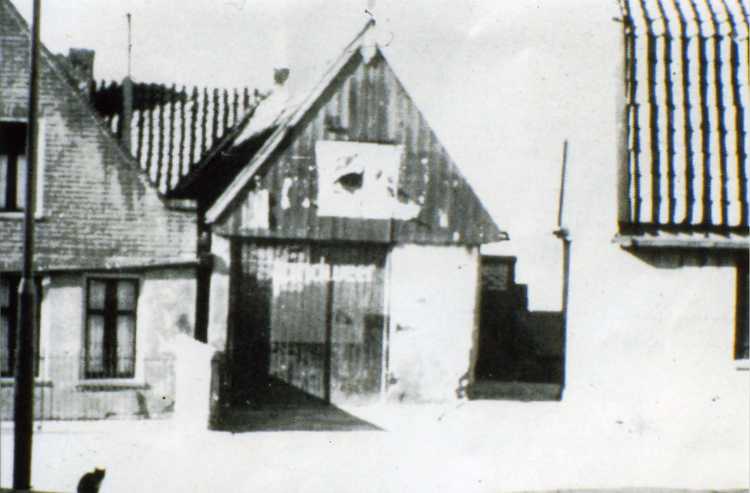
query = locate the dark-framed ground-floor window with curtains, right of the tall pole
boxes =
[84,278,138,378]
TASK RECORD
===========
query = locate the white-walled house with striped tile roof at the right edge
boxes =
[563,0,750,436]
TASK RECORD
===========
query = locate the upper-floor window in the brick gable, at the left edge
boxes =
[0,122,26,211]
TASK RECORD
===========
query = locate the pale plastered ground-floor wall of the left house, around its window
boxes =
[0,268,197,419]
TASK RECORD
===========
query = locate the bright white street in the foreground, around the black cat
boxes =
[2,402,750,493]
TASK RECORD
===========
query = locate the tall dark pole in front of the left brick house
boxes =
[13,0,41,490]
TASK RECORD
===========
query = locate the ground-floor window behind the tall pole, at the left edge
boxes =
[0,274,41,377]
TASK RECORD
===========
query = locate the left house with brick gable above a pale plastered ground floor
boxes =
[0,0,197,419]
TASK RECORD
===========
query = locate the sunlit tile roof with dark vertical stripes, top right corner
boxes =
[621,0,750,235]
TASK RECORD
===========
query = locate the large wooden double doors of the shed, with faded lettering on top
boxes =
[233,243,386,403]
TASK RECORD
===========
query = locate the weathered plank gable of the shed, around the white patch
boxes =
[215,50,503,244]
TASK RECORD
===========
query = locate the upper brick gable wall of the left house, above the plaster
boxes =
[0,0,196,271]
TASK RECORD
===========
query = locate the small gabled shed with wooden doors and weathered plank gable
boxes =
[175,22,507,404]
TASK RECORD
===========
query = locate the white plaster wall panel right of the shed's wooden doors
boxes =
[386,245,479,401]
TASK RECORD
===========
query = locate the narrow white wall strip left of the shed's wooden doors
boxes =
[208,235,230,351]
